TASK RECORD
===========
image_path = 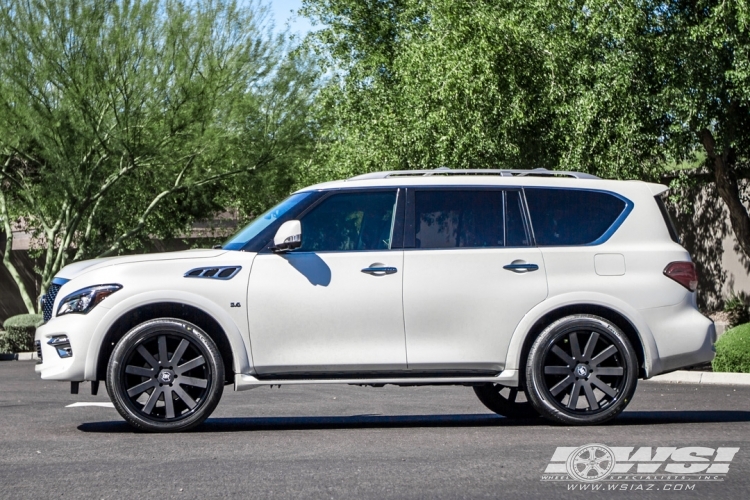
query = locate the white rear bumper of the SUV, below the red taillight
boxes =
[639,294,716,376]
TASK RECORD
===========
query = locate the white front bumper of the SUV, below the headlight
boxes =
[34,307,107,382]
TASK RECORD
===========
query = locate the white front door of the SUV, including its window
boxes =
[247,189,406,375]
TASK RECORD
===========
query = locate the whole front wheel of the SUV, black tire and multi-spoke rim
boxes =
[107,318,224,432]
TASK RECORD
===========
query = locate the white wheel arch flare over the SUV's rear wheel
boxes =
[505,292,660,378]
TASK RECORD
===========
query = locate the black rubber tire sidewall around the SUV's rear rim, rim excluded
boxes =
[526,314,638,425]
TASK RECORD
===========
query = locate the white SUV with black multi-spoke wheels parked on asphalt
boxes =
[36,169,715,431]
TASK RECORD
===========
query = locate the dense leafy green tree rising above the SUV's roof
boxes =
[303,0,750,250]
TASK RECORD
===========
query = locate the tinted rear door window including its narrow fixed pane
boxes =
[414,190,528,248]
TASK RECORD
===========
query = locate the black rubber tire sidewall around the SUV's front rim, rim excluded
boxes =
[106,318,224,432]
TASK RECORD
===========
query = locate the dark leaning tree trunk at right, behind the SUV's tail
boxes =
[699,129,750,257]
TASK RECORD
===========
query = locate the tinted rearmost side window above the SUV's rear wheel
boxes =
[525,188,625,246]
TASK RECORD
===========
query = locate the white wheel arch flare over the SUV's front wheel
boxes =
[85,290,251,380]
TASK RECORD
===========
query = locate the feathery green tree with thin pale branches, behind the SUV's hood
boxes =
[0,0,315,312]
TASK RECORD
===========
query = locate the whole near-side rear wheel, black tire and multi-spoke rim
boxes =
[526,314,638,425]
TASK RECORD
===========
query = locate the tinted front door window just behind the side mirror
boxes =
[300,191,396,252]
